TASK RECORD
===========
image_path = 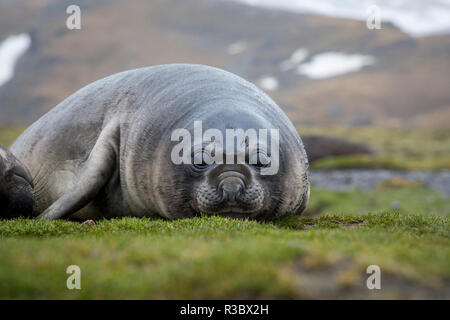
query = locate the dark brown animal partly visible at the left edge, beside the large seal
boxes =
[0,146,36,219]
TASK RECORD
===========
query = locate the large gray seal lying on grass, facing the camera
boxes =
[10,64,309,220]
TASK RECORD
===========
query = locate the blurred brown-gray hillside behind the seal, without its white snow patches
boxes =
[0,0,450,127]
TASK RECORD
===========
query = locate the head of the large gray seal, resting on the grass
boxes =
[191,110,309,220]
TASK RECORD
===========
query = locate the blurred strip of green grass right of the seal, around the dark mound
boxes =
[298,126,450,170]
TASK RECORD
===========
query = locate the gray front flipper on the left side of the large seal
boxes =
[38,124,119,220]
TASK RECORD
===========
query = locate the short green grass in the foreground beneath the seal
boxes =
[0,128,450,299]
